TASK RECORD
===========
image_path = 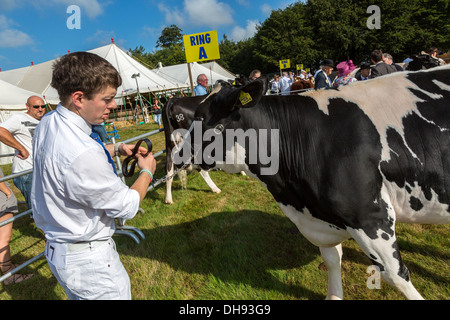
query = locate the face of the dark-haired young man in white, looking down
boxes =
[80,87,117,124]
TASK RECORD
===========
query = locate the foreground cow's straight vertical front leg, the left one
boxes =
[320,244,344,300]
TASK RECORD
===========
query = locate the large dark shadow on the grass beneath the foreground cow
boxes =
[118,210,326,300]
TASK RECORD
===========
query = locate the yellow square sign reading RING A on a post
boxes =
[183,30,220,63]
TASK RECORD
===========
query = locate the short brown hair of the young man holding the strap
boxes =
[51,52,122,104]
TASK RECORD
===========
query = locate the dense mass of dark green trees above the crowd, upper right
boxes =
[253,0,450,73]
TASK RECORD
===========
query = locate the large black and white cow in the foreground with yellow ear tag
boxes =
[181,66,450,299]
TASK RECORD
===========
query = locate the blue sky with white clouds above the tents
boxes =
[0,0,297,71]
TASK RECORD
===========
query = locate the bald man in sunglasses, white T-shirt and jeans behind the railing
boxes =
[0,96,45,209]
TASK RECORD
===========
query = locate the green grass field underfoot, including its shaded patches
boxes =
[0,124,450,300]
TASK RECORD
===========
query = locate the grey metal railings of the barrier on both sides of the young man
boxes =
[0,128,166,283]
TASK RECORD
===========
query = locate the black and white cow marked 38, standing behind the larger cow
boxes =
[162,96,221,204]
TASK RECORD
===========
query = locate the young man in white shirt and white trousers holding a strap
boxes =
[31,52,156,300]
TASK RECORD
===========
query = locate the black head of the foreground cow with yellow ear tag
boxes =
[192,77,268,169]
